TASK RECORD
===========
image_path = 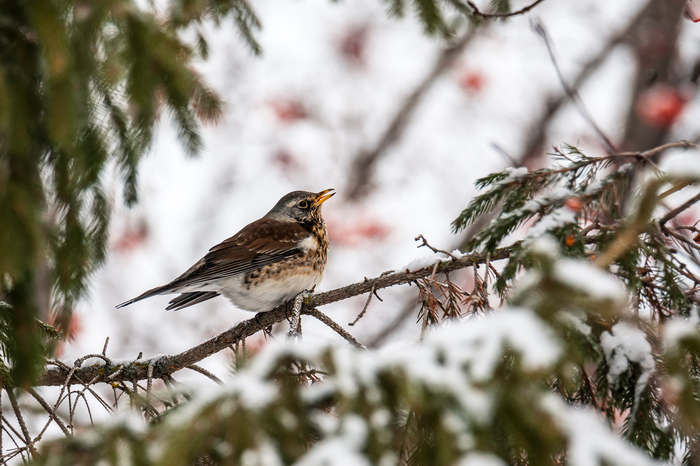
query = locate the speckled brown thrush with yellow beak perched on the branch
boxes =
[116,189,335,312]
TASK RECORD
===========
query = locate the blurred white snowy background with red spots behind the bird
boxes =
[60,0,700,377]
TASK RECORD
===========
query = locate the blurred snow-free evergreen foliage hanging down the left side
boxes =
[0,0,274,385]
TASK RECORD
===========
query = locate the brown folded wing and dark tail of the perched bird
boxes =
[117,218,309,309]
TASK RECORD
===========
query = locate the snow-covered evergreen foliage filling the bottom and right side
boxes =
[26,144,700,465]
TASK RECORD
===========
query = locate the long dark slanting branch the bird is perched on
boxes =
[38,248,511,386]
